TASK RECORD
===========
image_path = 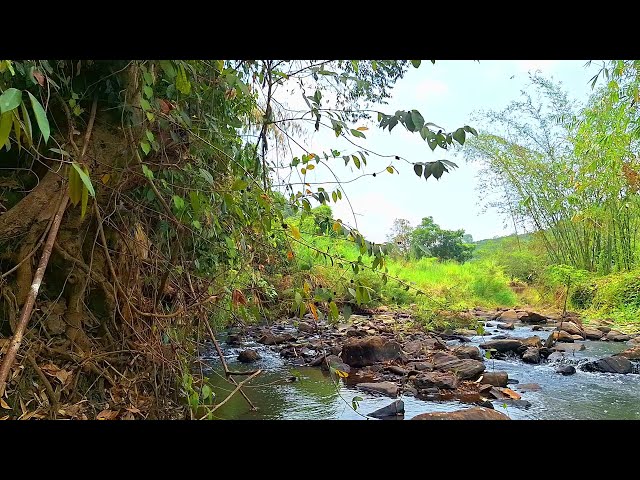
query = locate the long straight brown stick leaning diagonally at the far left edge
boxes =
[0,193,69,397]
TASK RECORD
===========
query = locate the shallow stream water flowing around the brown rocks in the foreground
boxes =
[204,326,640,420]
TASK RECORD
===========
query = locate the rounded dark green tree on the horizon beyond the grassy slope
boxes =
[411,217,474,263]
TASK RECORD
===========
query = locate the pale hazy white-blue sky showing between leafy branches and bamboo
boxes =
[270,60,599,242]
